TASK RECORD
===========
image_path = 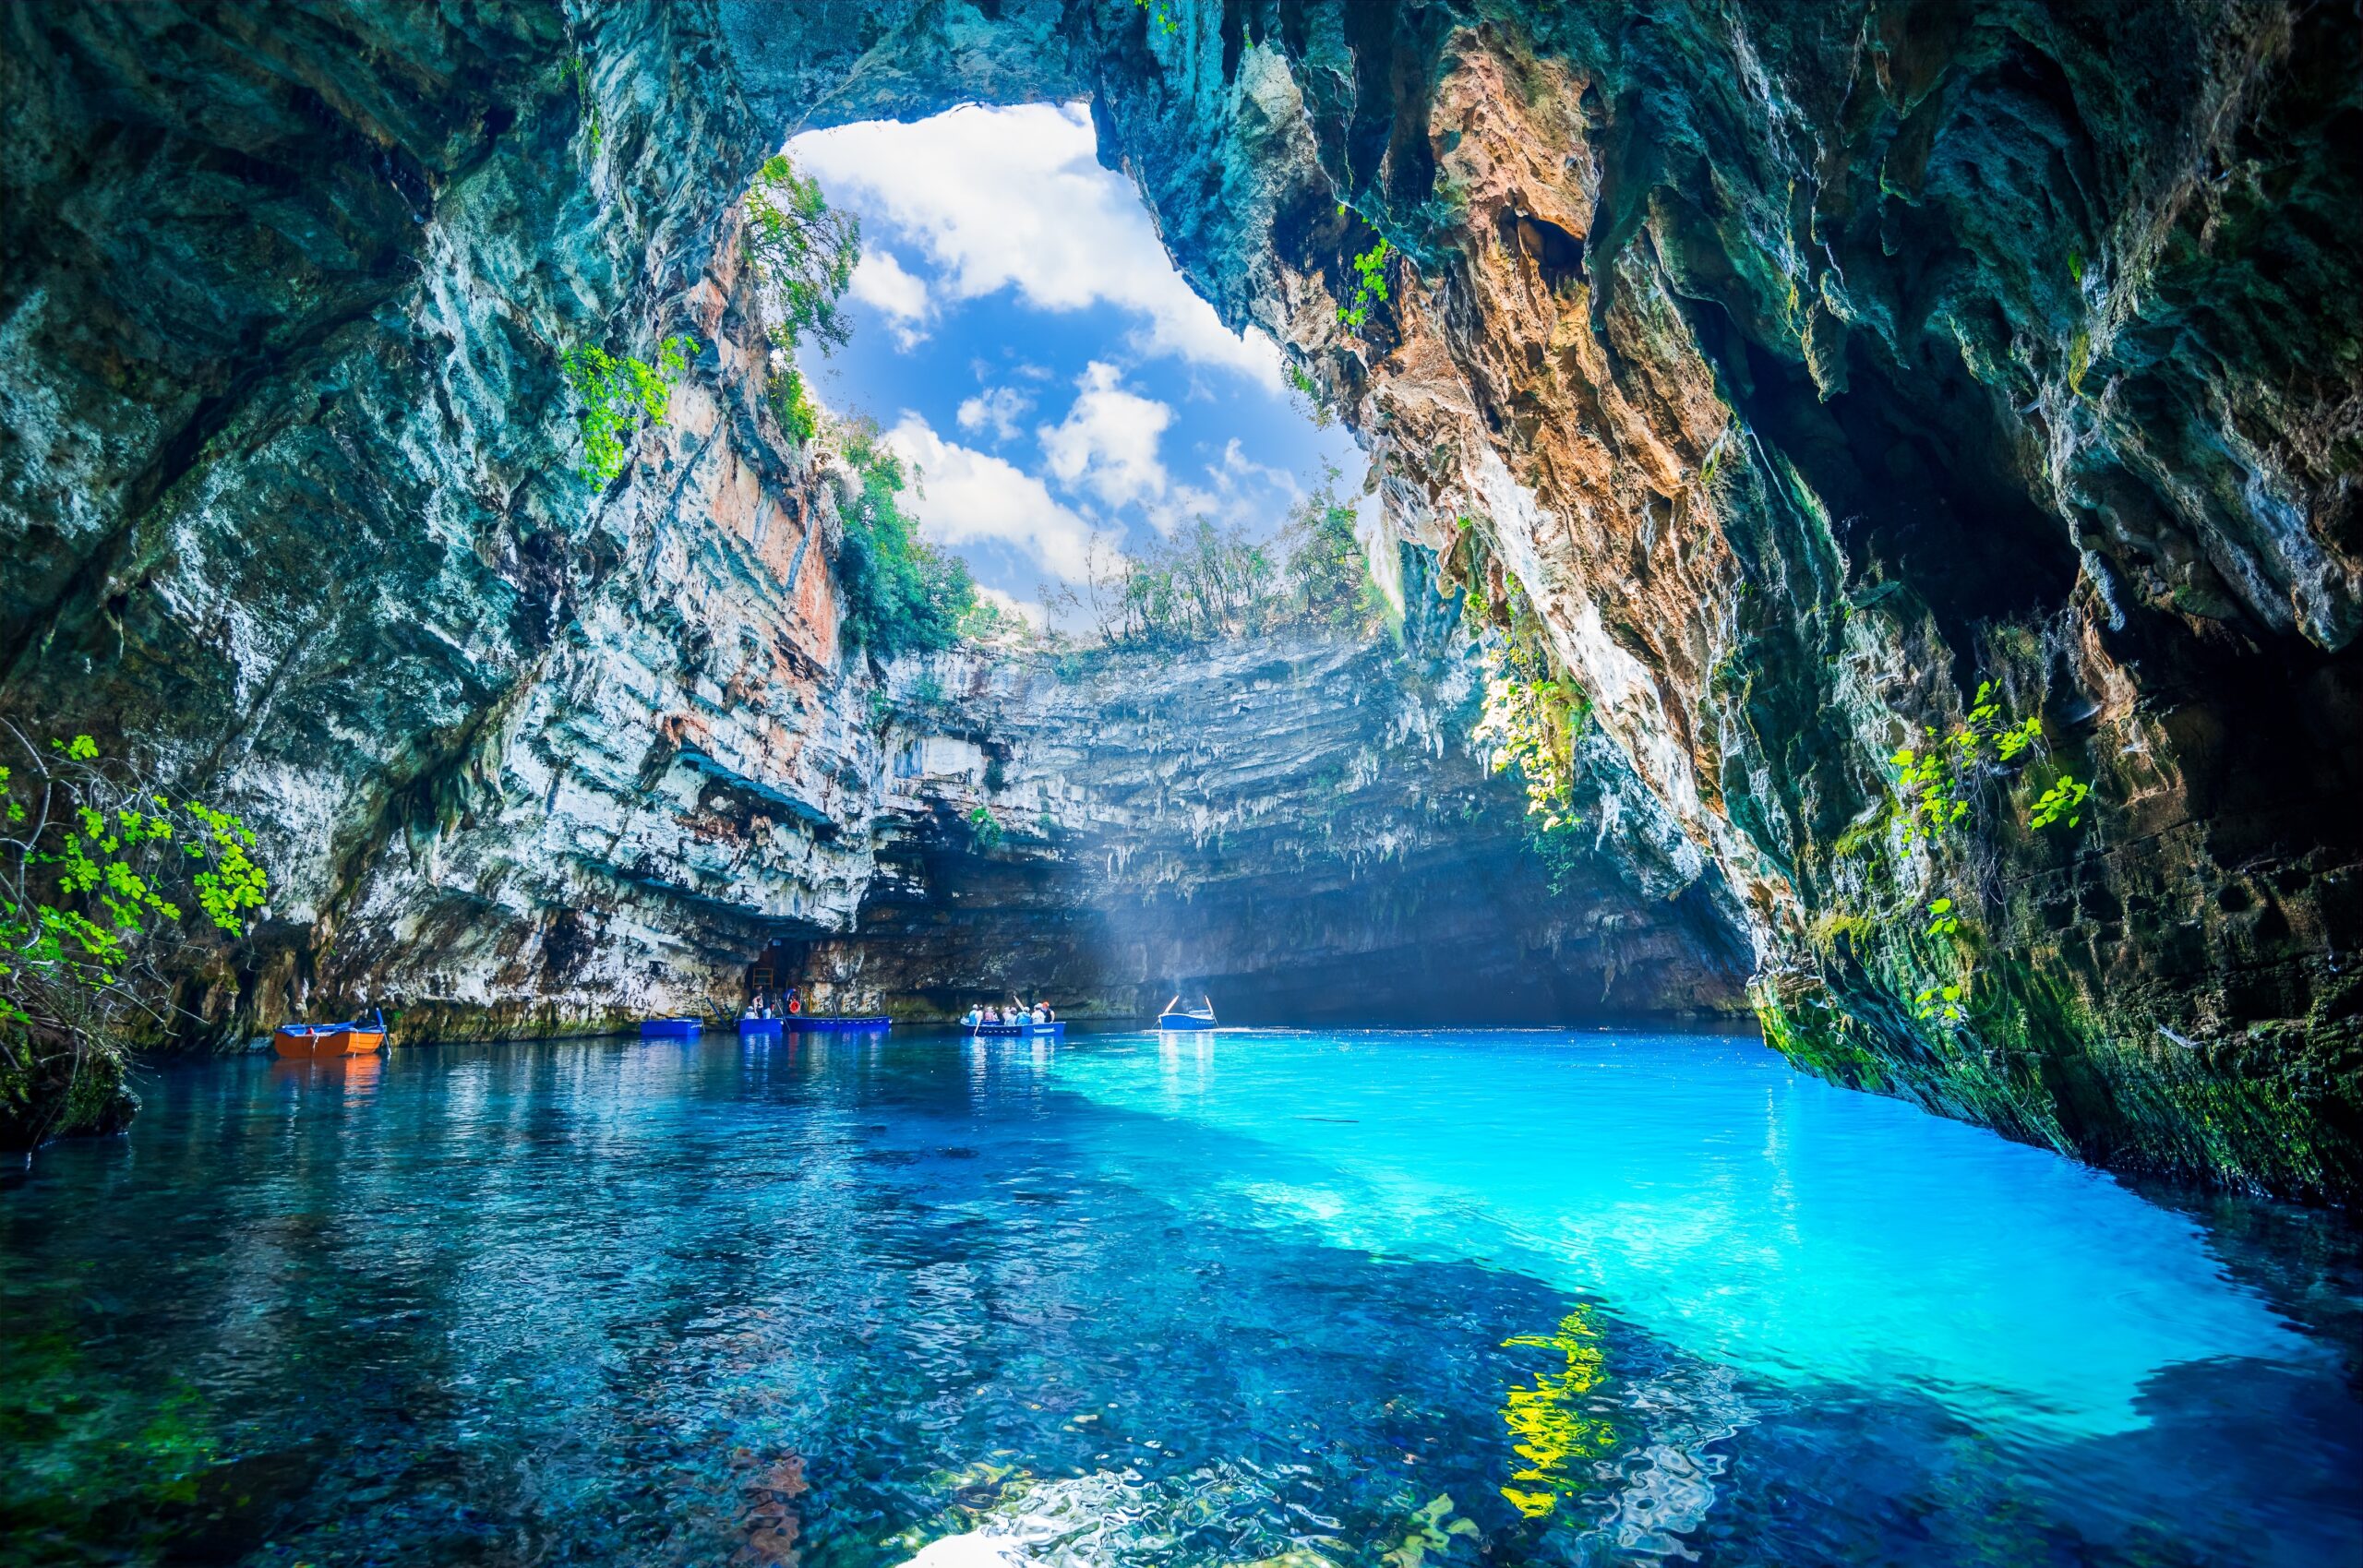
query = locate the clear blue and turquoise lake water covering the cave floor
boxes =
[0,1030,2363,1568]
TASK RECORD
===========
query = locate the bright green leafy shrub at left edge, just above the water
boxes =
[0,725,267,1148]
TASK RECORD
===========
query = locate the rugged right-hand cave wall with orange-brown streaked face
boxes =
[1002,3,2363,1192]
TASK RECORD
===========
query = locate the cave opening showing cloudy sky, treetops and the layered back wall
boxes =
[727,102,1742,1024]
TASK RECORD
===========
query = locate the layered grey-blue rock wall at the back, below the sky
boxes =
[780,633,1746,1023]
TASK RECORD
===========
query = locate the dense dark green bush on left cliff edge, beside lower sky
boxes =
[836,420,976,659]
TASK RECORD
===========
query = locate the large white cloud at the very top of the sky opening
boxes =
[789,104,1281,389]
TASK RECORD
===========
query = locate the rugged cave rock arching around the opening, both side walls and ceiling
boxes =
[0,0,2363,1195]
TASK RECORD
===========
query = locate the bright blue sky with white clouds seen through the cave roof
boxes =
[786,104,1363,623]
